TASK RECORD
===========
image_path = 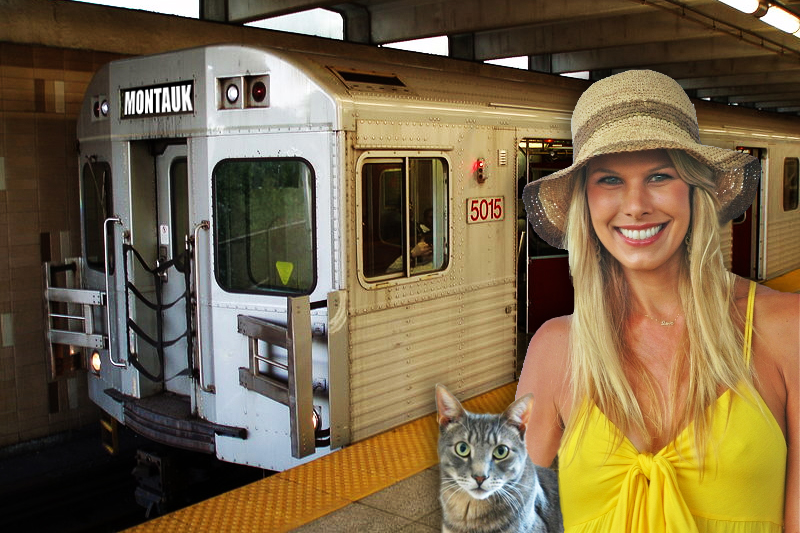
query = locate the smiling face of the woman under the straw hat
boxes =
[586,150,691,271]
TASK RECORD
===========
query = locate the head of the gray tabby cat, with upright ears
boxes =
[436,385,532,500]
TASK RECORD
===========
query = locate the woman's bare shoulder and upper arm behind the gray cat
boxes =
[517,316,571,466]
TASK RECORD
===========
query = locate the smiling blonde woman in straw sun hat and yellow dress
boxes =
[517,71,800,533]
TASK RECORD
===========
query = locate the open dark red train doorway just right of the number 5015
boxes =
[519,139,574,337]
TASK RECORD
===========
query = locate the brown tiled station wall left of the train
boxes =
[0,42,125,448]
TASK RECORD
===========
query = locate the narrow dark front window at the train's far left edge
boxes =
[81,161,113,272]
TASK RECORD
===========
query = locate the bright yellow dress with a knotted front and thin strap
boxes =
[559,284,787,533]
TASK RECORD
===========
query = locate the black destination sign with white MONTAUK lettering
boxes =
[120,81,194,118]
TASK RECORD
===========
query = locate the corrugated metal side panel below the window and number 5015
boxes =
[350,280,516,440]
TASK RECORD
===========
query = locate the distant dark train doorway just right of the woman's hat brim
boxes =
[731,146,767,279]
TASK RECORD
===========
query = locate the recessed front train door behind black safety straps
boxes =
[125,141,192,396]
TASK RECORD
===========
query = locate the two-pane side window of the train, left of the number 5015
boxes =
[360,157,449,281]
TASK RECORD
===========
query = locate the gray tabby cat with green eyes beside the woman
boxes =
[436,385,564,533]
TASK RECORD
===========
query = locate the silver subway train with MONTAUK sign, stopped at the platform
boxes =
[45,45,800,470]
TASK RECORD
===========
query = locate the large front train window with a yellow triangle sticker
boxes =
[213,159,316,295]
